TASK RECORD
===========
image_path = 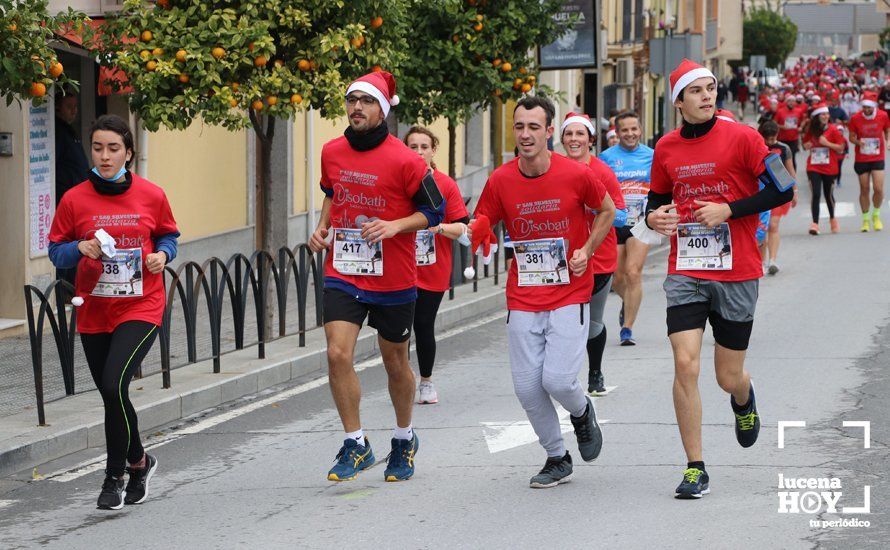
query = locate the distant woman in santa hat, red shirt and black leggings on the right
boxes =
[803,103,847,235]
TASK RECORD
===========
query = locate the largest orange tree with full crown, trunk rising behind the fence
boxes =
[101,0,407,251]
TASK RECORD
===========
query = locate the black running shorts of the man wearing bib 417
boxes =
[324,288,414,343]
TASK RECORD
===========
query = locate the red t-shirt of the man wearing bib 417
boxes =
[321,135,429,292]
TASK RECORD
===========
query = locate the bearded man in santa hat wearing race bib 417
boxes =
[309,71,445,481]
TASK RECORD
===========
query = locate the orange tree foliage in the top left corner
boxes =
[0,0,89,106]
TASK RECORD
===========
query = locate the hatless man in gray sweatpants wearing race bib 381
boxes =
[475,97,615,488]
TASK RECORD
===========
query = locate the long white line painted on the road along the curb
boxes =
[44,311,506,483]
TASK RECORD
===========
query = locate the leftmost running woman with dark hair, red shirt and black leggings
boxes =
[49,115,179,510]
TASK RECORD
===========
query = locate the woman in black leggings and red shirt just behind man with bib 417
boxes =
[405,126,470,404]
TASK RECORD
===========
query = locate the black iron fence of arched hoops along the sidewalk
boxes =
[24,235,507,426]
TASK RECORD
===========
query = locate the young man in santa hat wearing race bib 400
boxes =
[645,59,793,498]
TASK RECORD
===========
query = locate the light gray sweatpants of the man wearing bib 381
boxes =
[507,303,590,457]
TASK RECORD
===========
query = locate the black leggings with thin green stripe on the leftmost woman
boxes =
[80,321,158,477]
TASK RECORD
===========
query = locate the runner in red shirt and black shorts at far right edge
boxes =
[848,92,890,233]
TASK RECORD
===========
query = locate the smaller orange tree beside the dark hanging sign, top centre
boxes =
[396,0,567,177]
